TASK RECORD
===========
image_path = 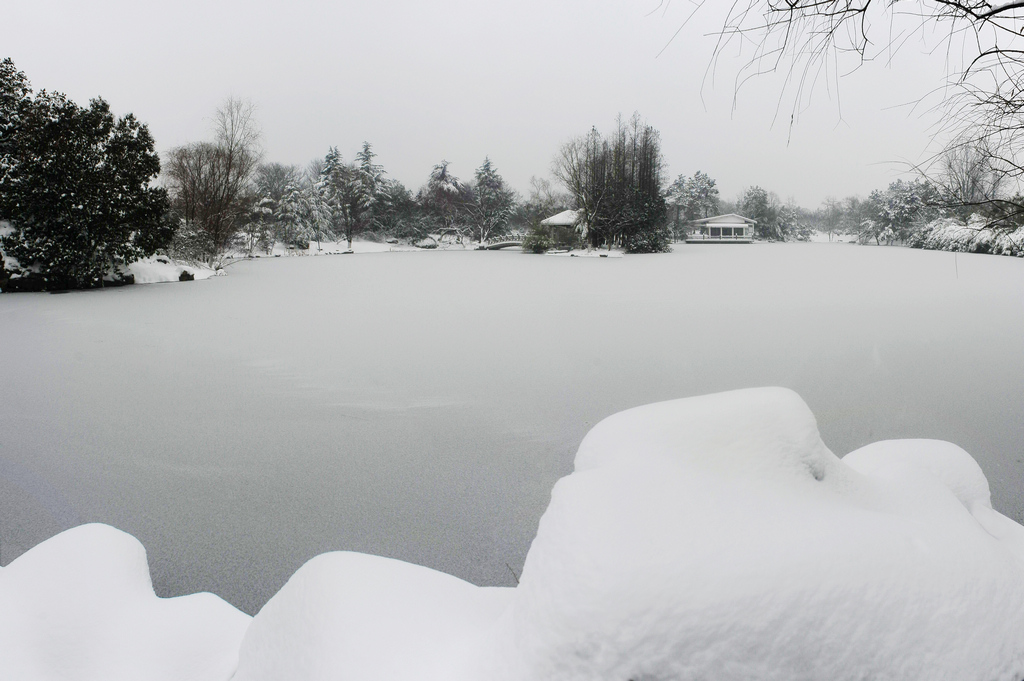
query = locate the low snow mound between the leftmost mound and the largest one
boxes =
[234,552,514,681]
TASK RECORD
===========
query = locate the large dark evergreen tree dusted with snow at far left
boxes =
[0,58,173,290]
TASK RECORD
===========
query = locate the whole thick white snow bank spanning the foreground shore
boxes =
[0,388,1024,681]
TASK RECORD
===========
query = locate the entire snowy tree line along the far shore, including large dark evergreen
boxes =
[8,50,1024,289]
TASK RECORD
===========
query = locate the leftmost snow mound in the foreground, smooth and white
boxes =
[0,524,250,681]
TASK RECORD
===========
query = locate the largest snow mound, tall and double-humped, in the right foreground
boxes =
[466,388,1024,681]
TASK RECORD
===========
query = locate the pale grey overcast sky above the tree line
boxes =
[0,0,943,208]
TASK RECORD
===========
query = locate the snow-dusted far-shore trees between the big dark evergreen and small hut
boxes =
[165,99,522,263]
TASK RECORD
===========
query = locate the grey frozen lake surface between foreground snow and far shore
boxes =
[0,244,1024,612]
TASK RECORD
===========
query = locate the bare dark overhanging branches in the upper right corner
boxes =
[688,0,1024,223]
